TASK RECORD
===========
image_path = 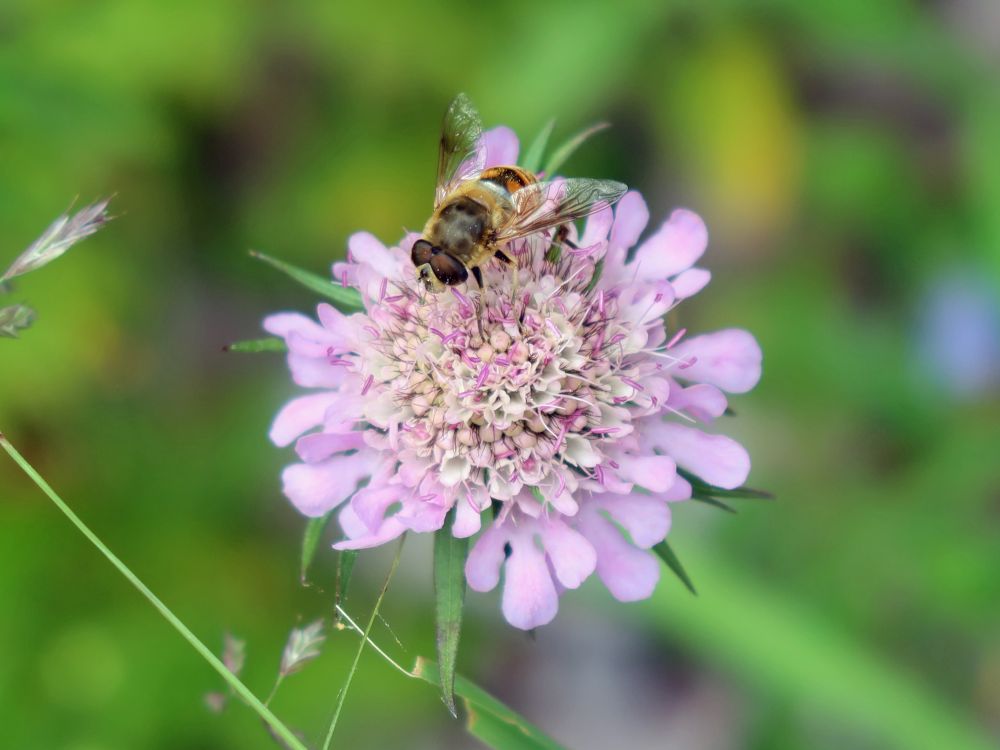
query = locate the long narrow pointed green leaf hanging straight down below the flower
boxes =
[434,508,469,716]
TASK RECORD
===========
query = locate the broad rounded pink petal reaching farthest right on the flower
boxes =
[670,328,761,393]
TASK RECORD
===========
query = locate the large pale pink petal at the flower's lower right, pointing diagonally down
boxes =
[579,512,660,602]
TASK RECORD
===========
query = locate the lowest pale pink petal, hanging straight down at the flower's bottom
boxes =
[502,532,559,630]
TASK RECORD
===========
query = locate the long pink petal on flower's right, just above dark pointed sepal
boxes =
[647,422,750,490]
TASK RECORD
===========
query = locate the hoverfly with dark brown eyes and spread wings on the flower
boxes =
[410,94,628,300]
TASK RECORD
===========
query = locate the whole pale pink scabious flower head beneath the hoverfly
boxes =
[264,128,761,629]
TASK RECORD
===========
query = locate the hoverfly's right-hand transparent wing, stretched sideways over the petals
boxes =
[496,178,628,244]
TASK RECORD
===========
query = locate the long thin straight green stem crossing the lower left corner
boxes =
[0,433,307,750]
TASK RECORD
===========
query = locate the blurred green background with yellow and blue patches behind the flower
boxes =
[0,0,1000,750]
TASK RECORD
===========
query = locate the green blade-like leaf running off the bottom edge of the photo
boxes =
[413,657,563,750]
